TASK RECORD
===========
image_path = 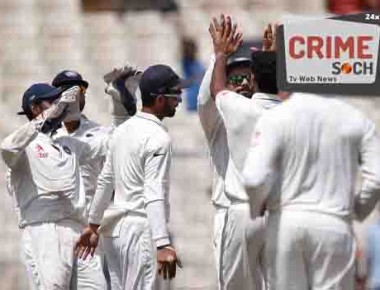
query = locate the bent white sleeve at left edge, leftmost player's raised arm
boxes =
[1,121,38,167]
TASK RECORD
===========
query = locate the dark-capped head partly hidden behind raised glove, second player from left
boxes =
[52,70,88,111]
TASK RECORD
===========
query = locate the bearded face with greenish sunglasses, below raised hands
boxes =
[227,66,255,98]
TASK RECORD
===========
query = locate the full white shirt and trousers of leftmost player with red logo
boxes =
[1,122,108,289]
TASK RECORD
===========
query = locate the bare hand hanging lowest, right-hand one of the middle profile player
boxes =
[157,245,182,280]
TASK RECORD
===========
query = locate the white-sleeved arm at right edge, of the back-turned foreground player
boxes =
[354,121,380,220]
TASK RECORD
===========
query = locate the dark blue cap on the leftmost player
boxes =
[17,83,62,115]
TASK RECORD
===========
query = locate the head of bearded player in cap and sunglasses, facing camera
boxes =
[227,48,255,98]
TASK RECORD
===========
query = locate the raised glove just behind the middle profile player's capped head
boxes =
[103,65,141,116]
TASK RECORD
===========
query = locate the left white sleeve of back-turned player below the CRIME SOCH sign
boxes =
[242,116,282,201]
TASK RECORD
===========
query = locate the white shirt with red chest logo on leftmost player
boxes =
[1,122,108,228]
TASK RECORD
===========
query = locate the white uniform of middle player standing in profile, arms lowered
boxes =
[89,112,171,290]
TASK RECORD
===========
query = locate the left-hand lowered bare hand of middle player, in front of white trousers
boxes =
[74,225,99,260]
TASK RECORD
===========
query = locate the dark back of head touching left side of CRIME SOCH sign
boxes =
[252,50,278,94]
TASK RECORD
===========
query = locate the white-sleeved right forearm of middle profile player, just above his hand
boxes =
[146,200,170,247]
